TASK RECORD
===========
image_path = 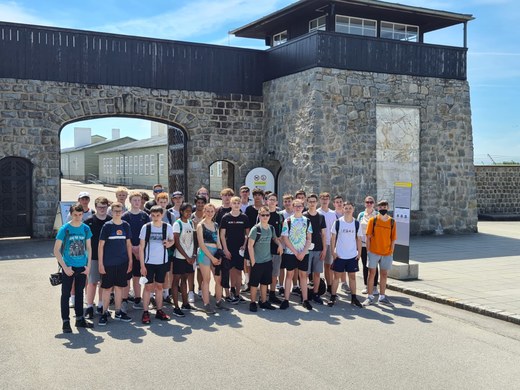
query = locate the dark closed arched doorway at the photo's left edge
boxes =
[0,157,33,237]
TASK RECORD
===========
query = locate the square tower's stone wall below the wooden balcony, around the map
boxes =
[264,68,477,234]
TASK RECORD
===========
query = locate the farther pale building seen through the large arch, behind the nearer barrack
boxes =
[61,127,135,182]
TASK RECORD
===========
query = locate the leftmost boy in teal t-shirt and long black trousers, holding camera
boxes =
[54,203,93,333]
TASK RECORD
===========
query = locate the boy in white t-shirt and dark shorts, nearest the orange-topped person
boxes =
[329,202,363,307]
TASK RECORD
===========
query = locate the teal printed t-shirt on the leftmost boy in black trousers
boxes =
[56,222,92,267]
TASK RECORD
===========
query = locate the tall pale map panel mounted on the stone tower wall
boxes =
[376,105,420,210]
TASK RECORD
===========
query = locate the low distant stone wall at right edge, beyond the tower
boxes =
[475,165,520,216]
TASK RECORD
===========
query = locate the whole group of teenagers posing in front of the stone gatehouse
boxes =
[54,184,396,333]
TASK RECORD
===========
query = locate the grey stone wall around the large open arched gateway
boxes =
[0,79,264,237]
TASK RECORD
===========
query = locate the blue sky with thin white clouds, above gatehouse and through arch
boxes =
[0,0,520,164]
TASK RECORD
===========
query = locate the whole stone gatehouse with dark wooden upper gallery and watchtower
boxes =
[0,0,477,237]
